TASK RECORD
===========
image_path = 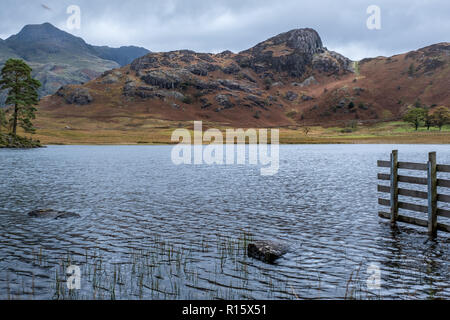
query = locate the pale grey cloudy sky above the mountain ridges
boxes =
[0,0,450,59]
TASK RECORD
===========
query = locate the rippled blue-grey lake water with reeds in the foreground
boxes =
[0,145,450,299]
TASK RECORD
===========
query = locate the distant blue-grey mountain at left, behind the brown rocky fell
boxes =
[0,23,149,100]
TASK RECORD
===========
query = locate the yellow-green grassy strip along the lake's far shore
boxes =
[12,121,450,145]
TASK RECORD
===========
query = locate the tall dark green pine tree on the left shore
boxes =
[0,59,41,135]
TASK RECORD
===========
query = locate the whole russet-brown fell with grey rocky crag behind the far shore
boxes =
[34,29,450,130]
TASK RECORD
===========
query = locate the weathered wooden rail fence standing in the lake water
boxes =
[378,150,450,236]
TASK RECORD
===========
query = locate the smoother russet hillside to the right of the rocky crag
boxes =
[296,43,450,123]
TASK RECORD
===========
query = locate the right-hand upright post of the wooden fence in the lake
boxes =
[428,152,437,237]
